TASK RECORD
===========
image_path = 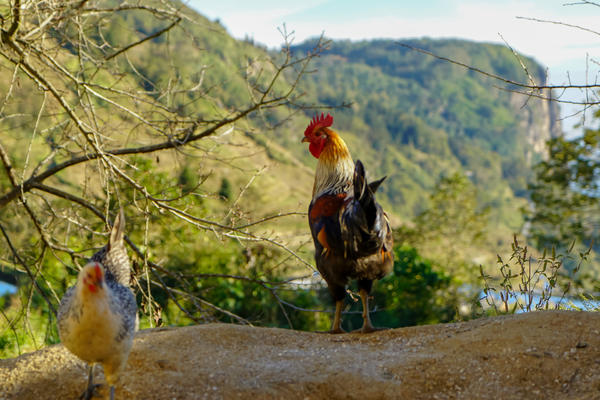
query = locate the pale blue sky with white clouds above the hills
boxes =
[187,0,600,133]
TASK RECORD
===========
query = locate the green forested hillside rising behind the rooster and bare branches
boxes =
[0,0,572,355]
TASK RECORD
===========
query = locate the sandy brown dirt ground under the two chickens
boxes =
[0,311,600,400]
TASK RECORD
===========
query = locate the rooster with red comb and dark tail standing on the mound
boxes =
[302,114,393,333]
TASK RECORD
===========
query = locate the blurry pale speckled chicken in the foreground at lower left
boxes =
[57,210,138,400]
